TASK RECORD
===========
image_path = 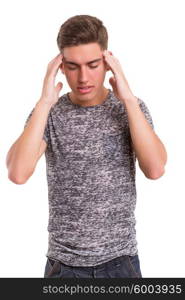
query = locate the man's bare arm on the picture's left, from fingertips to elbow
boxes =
[6,54,63,184]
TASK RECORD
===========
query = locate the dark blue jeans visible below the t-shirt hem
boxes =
[44,255,142,278]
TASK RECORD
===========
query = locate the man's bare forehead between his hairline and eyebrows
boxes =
[63,43,103,64]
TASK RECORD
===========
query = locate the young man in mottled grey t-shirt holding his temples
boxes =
[7,15,167,278]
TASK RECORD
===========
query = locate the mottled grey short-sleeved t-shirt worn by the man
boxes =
[25,89,154,266]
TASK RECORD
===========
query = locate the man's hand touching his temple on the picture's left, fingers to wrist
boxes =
[40,53,63,106]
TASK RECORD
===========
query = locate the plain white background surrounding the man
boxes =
[0,0,185,277]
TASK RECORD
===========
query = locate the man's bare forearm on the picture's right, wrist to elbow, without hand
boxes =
[124,97,167,179]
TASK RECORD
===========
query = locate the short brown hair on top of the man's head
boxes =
[57,15,108,53]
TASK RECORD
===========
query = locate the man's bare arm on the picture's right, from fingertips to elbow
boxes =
[103,50,167,179]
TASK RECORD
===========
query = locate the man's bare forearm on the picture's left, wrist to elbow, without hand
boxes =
[6,100,51,181]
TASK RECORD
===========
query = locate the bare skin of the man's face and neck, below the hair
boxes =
[60,43,109,106]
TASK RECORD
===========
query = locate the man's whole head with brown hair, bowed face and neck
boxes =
[57,15,109,105]
